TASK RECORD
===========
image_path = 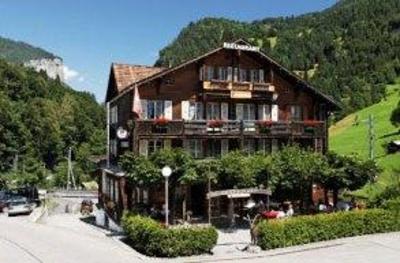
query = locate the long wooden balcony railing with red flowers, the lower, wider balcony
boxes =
[134,120,326,137]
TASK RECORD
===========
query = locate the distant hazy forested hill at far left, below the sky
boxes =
[0,37,56,63]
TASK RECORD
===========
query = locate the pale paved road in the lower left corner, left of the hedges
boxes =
[0,214,144,263]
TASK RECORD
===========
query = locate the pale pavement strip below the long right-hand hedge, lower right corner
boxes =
[175,232,400,263]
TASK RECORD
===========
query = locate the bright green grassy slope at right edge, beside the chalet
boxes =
[329,79,400,193]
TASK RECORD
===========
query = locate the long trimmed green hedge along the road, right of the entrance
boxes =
[257,209,400,250]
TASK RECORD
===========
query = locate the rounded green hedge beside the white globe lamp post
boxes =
[122,213,218,257]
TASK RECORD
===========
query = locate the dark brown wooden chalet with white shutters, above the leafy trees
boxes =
[101,40,338,224]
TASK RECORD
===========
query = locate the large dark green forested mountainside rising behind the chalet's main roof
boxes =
[156,0,400,116]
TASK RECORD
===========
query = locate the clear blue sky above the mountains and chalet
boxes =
[0,0,337,102]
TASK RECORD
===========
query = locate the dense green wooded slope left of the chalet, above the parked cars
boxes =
[0,60,105,189]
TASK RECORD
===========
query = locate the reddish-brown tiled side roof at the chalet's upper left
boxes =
[112,63,164,92]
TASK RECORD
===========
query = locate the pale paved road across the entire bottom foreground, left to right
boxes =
[0,214,400,263]
